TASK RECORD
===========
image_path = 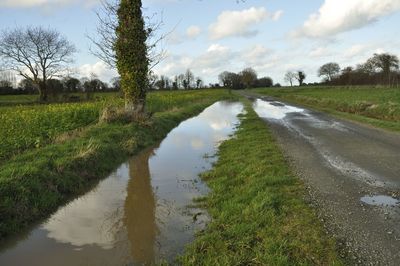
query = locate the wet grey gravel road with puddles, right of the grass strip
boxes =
[242,93,400,265]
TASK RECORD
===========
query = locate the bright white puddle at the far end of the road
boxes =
[253,99,304,119]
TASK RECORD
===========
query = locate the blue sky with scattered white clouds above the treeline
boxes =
[0,0,400,85]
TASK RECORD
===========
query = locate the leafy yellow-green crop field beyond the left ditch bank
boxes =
[0,90,230,163]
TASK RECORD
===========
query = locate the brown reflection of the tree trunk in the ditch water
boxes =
[124,149,157,264]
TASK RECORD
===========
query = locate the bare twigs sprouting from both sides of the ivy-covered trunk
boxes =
[87,0,169,71]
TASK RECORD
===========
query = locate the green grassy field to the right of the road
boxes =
[254,87,400,131]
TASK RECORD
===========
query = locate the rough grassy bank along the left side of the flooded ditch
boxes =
[0,92,233,241]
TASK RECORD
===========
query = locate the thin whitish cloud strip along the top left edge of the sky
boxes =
[0,0,99,8]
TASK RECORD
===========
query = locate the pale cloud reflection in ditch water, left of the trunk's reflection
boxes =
[43,168,128,249]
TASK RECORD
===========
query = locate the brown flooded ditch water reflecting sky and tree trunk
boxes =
[0,102,243,266]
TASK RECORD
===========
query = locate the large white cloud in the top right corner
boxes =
[293,0,400,38]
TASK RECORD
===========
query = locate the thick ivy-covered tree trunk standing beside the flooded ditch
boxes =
[115,0,149,117]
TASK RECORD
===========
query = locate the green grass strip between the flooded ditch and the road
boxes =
[179,103,342,265]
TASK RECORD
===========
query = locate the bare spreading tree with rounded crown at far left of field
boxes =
[0,27,76,101]
